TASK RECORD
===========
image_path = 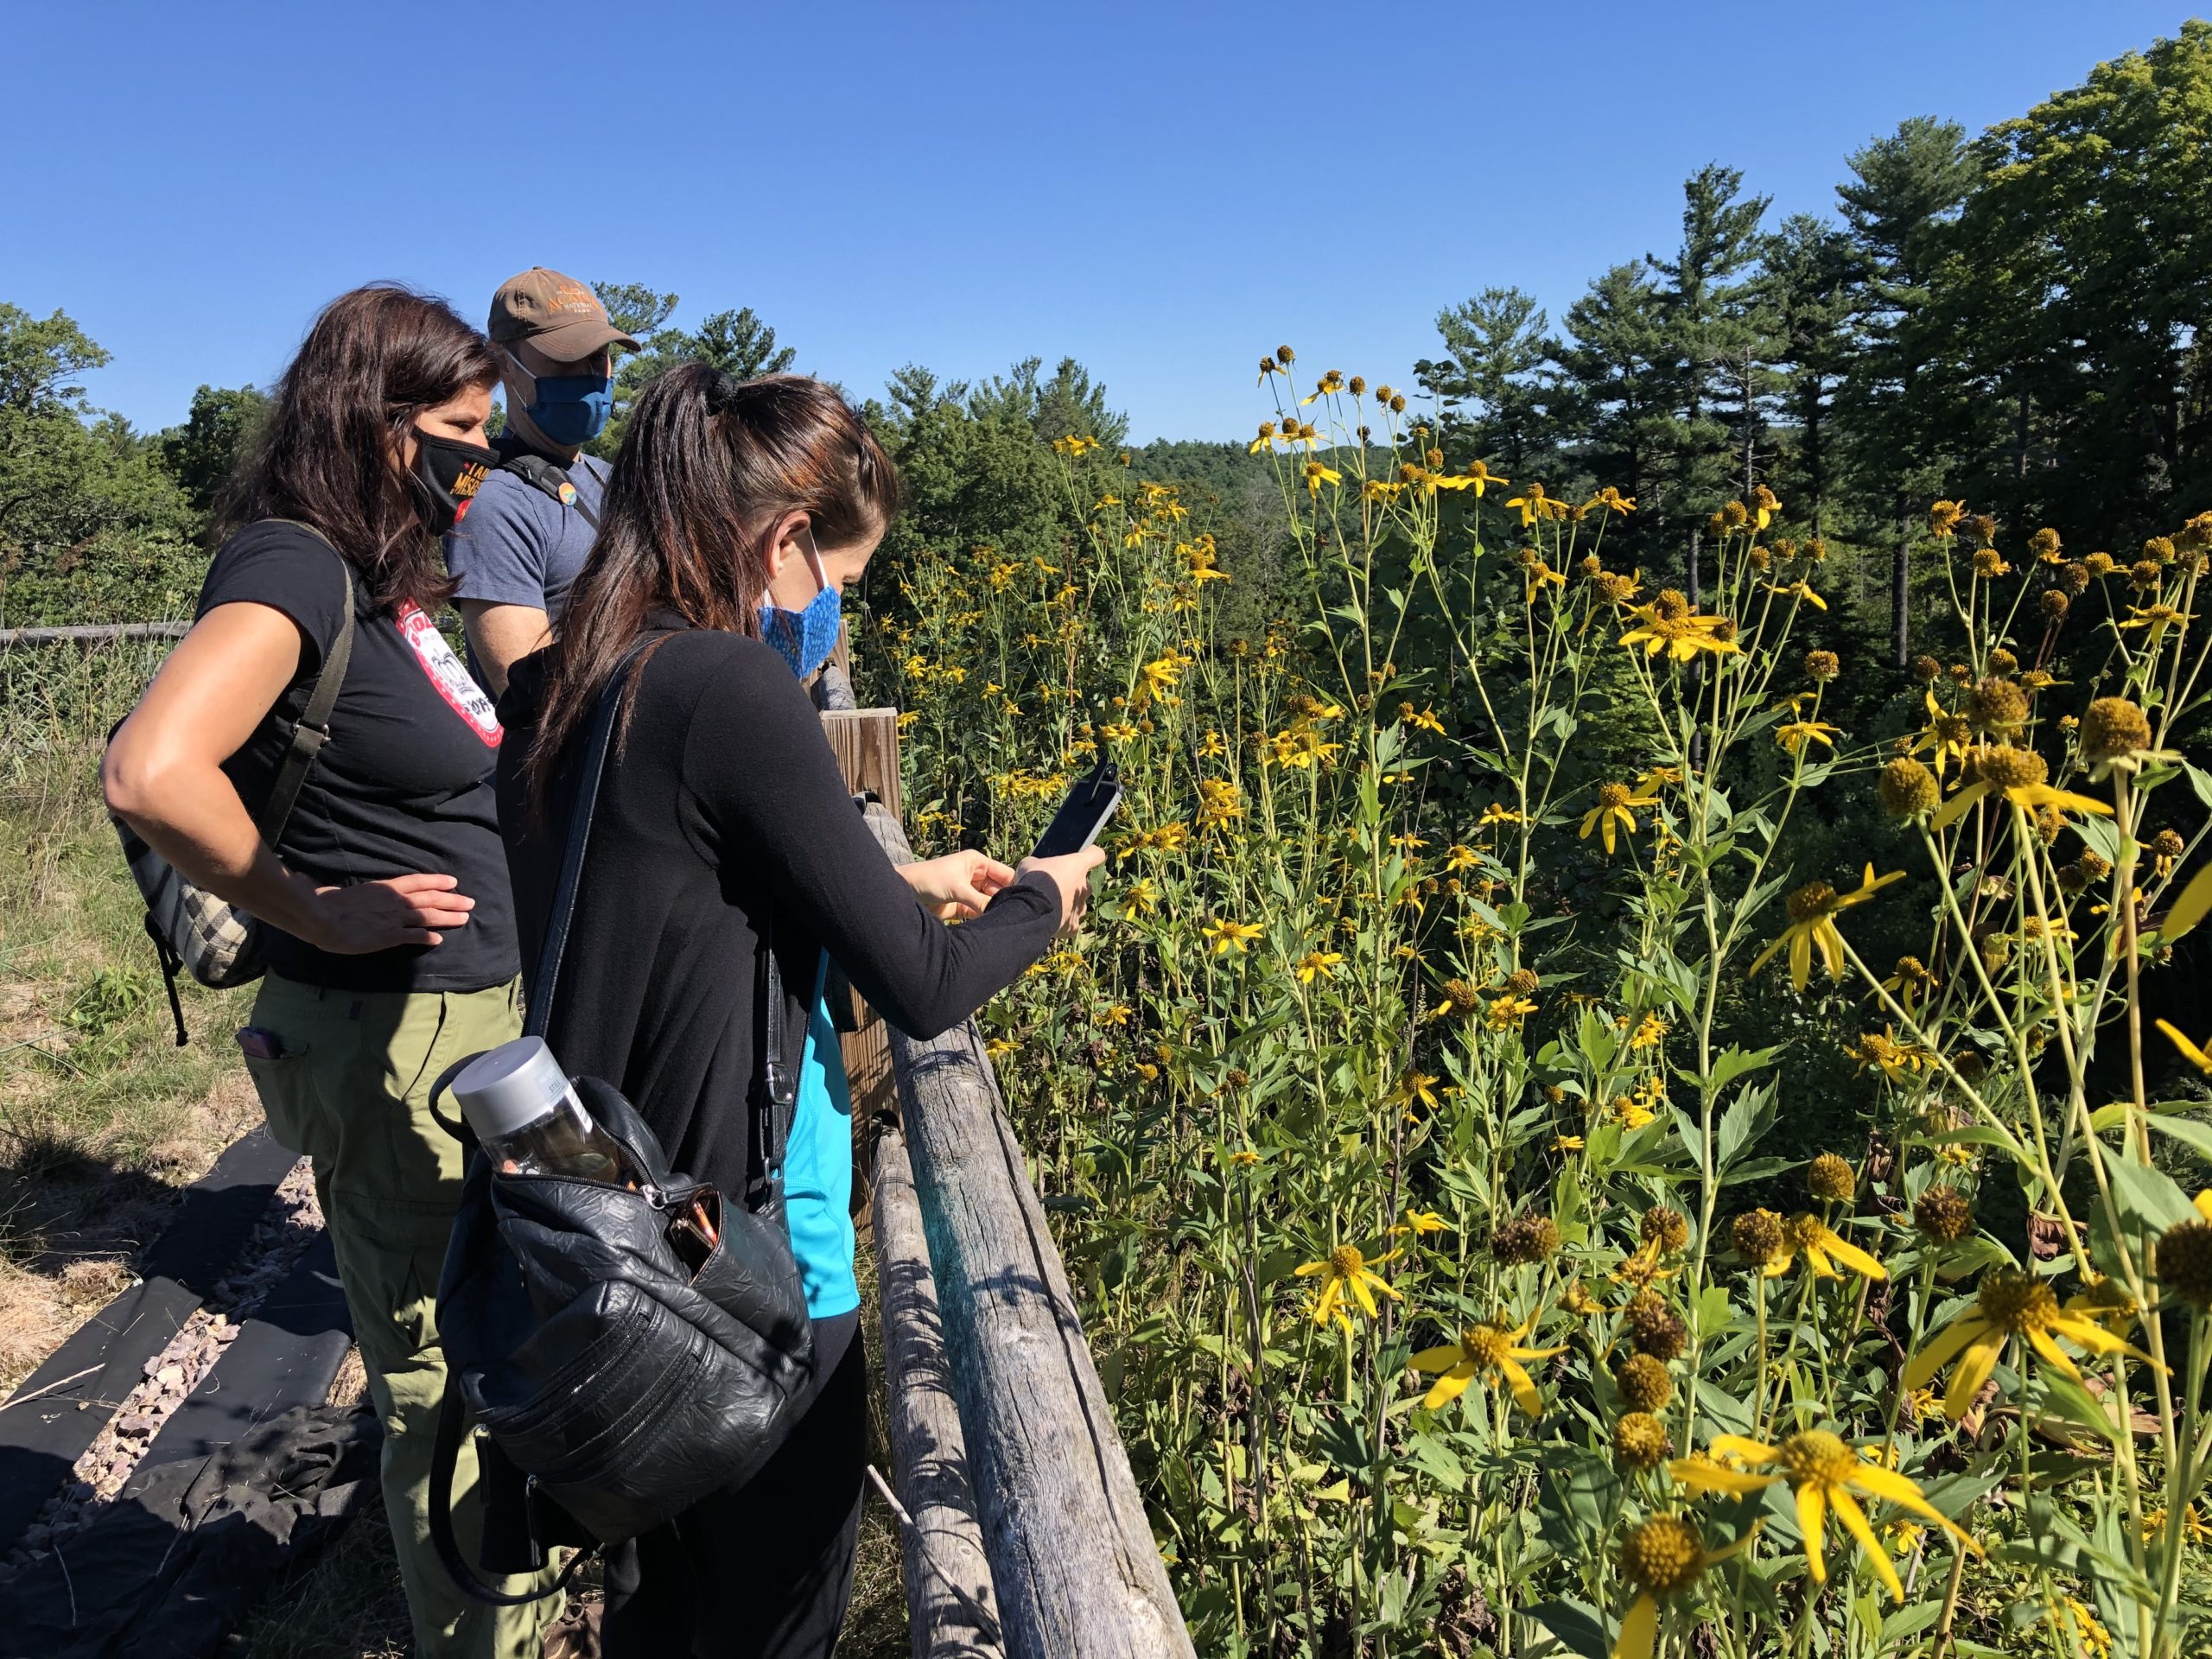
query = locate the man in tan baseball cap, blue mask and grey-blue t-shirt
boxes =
[445,265,637,696]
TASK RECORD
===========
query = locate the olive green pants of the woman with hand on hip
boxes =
[245,973,562,1659]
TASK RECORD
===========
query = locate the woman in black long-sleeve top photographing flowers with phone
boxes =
[500,365,1099,1659]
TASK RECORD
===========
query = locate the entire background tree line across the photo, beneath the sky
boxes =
[0,22,2212,645]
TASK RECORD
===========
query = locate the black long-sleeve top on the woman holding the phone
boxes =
[498,620,1059,1192]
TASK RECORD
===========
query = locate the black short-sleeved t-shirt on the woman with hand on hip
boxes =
[199,522,518,991]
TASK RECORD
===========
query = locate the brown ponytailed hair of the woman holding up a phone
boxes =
[524,373,898,810]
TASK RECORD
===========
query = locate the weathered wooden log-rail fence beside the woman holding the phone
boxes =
[817,668,1192,1659]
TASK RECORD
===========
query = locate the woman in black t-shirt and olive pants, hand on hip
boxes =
[102,285,557,1659]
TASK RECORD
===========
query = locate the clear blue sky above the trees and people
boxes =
[0,0,2188,440]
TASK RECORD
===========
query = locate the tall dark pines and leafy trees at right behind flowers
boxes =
[1415,22,2212,666]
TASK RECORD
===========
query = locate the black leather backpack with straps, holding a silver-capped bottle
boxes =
[429,654,814,1604]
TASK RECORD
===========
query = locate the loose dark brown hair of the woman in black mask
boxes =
[217,283,500,611]
